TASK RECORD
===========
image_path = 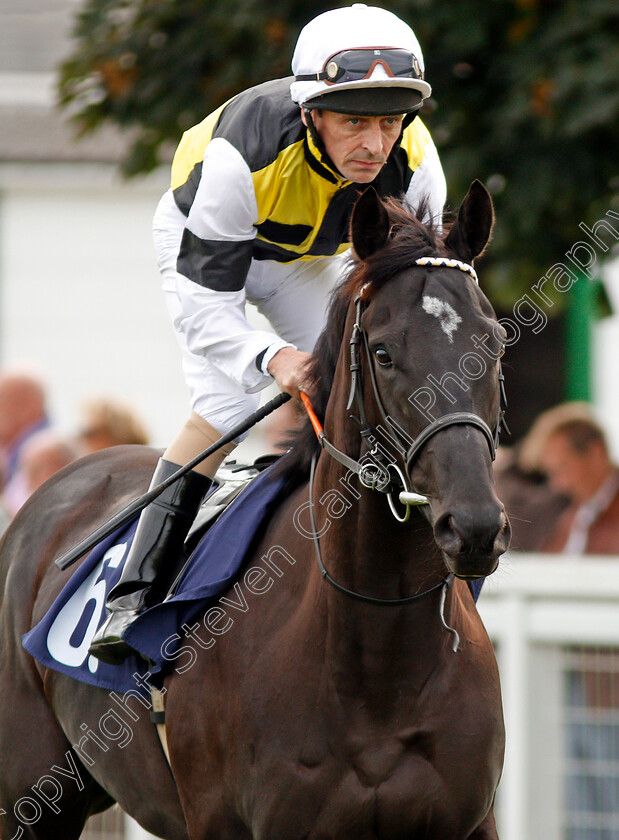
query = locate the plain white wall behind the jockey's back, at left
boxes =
[0,164,272,451]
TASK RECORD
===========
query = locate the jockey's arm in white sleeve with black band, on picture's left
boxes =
[155,140,297,393]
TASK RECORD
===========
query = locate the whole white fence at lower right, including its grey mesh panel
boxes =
[478,554,619,840]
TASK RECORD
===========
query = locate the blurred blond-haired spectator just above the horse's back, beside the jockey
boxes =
[78,397,148,453]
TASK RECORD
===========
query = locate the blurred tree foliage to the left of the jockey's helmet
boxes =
[60,0,328,176]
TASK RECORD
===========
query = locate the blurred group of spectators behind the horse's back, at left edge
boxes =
[0,368,148,532]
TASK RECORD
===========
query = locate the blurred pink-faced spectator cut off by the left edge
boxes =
[0,369,49,516]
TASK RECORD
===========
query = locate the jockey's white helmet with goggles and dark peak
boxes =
[290,3,432,116]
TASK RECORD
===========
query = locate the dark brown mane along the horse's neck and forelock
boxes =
[279,198,446,481]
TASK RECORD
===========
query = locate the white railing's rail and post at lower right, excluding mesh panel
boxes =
[478,554,619,840]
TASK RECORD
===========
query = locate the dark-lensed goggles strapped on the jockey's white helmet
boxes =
[295,47,423,85]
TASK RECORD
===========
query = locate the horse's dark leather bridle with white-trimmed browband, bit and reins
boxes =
[301,257,509,624]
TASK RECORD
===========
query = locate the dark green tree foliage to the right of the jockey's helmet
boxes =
[399,0,619,304]
